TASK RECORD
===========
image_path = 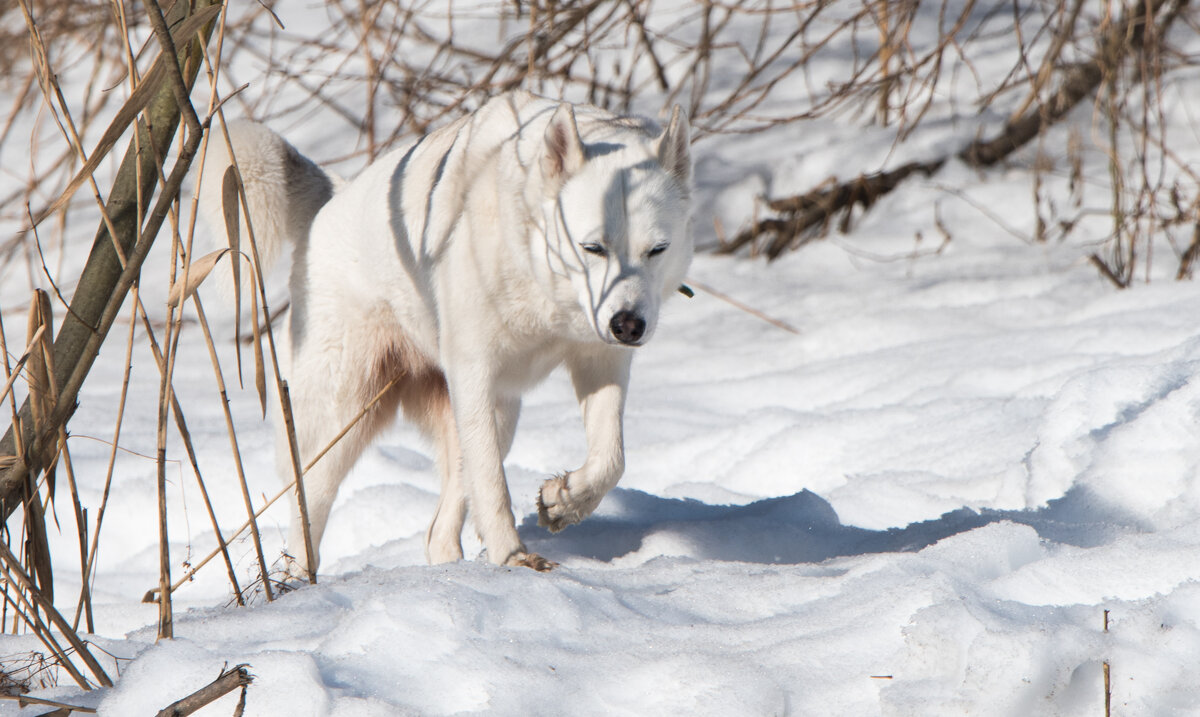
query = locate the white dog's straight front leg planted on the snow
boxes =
[446,363,554,571]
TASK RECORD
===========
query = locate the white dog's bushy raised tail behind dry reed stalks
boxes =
[198,120,334,279]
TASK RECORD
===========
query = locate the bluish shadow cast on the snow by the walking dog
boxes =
[520,487,1141,564]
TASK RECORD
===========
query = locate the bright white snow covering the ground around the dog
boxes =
[0,0,1200,716]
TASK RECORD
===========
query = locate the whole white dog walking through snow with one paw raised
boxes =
[200,92,692,571]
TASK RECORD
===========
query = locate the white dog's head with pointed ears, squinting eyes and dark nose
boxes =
[541,103,692,347]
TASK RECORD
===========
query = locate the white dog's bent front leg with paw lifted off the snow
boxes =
[538,347,632,532]
